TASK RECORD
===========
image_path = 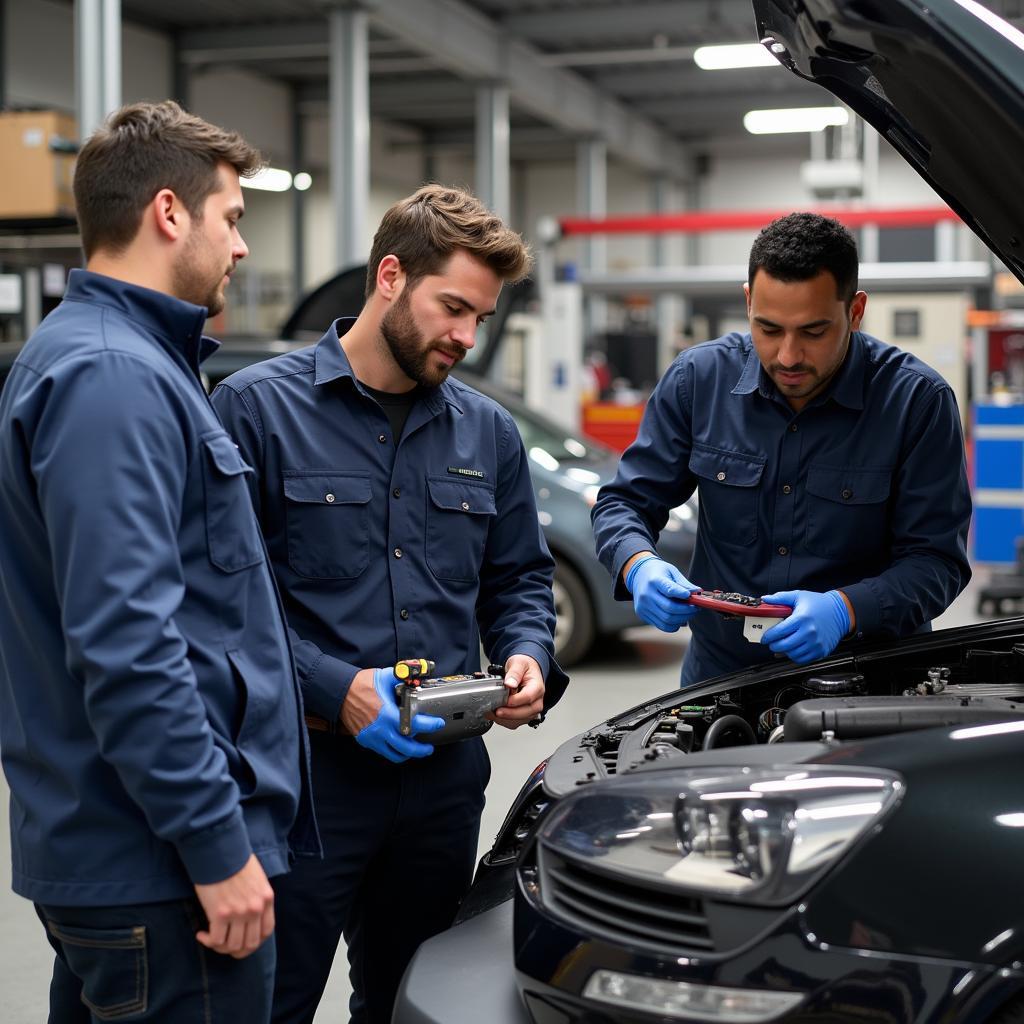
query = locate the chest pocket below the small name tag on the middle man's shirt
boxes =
[426,476,496,583]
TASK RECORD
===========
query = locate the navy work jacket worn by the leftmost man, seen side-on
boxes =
[0,270,318,906]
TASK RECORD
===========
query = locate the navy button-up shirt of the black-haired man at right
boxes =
[593,332,971,685]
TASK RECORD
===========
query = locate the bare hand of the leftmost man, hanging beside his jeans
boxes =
[196,854,273,959]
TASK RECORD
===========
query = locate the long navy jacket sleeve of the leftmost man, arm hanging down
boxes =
[32,352,252,883]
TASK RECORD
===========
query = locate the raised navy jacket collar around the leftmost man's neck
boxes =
[65,269,220,374]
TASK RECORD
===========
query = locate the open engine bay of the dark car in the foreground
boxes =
[546,627,1024,793]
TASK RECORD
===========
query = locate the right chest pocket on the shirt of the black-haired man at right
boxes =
[806,463,892,558]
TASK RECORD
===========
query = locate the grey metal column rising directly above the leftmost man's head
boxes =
[75,0,121,139]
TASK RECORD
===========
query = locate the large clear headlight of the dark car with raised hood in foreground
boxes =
[541,765,904,905]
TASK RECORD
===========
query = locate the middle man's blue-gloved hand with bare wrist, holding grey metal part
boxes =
[341,669,444,764]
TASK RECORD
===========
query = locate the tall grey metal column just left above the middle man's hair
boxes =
[328,9,370,269]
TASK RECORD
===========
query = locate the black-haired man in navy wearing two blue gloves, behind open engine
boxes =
[593,213,971,686]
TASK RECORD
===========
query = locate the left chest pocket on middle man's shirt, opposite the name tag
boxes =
[284,470,371,580]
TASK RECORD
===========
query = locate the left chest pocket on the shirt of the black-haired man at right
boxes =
[689,444,765,546]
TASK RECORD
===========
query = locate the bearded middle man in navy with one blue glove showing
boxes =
[213,185,566,1024]
